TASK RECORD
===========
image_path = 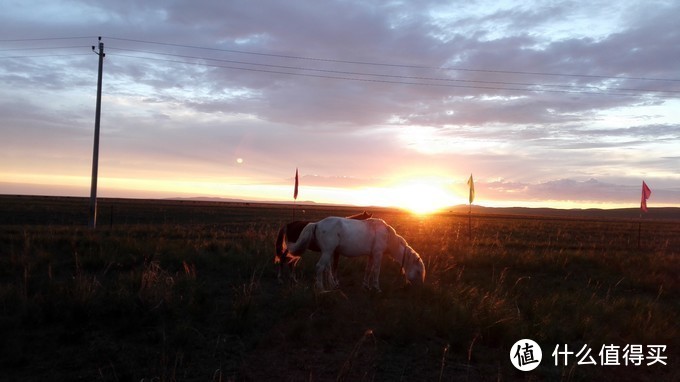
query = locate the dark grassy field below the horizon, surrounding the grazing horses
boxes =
[0,196,680,381]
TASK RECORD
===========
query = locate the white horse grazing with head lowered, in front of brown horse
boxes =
[286,217,425,291]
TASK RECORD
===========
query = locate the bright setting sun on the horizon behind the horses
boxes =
[391,181,455,215]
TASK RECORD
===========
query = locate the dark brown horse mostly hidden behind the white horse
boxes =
[274,211,373,281]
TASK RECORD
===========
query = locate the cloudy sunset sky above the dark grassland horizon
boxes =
[0,0,680,211]
